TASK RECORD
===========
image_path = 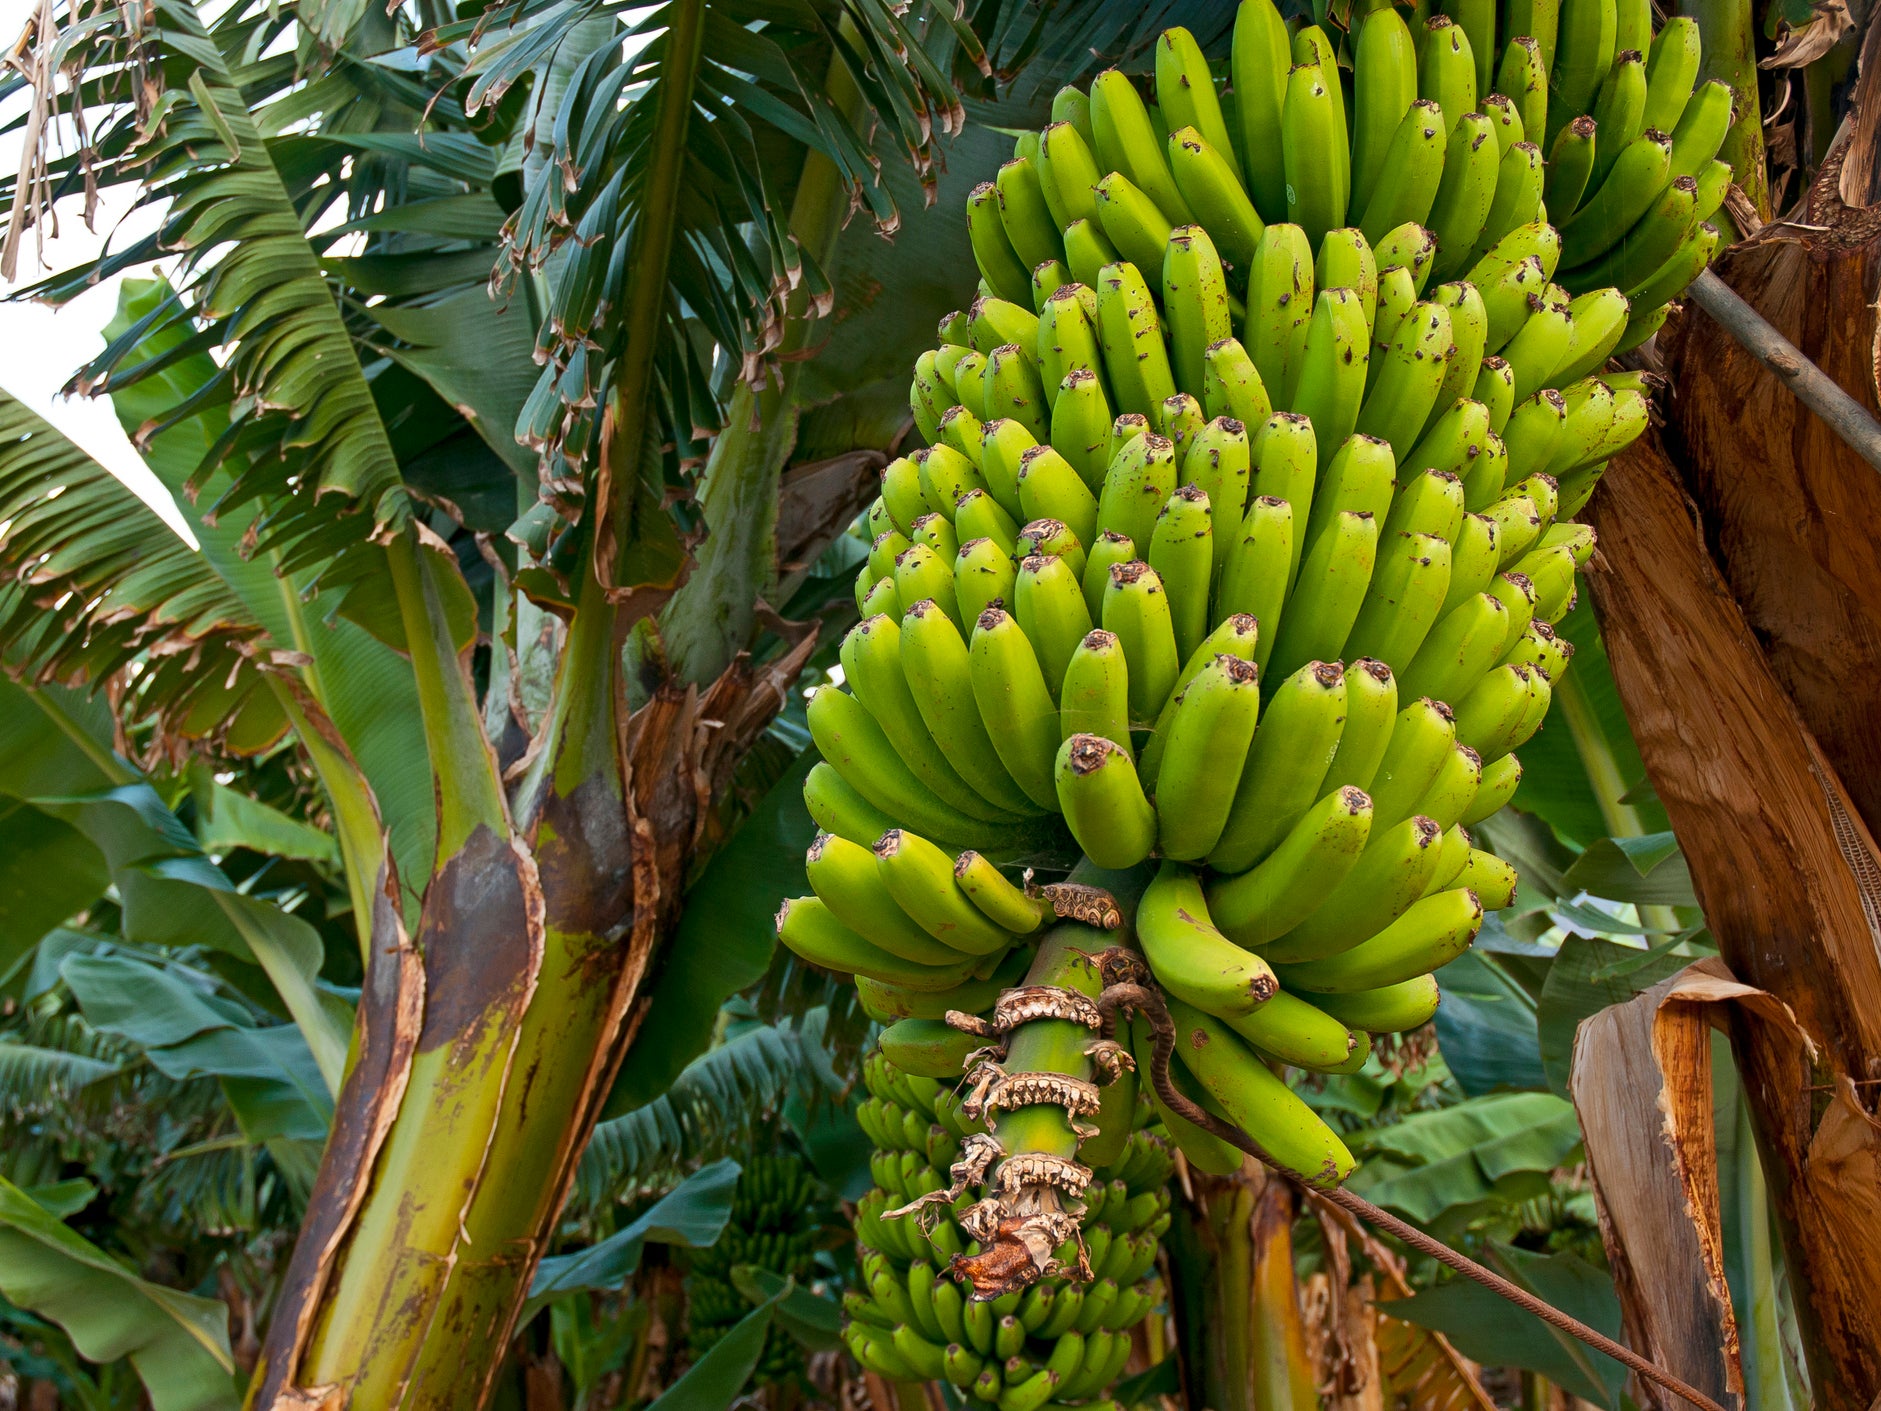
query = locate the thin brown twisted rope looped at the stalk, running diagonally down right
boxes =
[1097,984,1727,1411]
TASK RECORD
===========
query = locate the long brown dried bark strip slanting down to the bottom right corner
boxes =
[1588,436,1881,1411]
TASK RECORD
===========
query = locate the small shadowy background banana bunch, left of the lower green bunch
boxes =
[685,1151,837,1385]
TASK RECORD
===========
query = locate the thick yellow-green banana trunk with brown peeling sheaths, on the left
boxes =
[250,534,809,1411]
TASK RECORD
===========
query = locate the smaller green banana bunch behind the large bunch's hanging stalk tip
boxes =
[843,1053,1174,1411]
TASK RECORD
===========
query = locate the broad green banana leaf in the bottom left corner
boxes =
[0,1180,241,1411]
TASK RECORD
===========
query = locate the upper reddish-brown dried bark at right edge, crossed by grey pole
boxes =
[1659,135,1881,832]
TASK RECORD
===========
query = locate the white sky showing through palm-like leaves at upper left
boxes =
[0,0,194,542]
